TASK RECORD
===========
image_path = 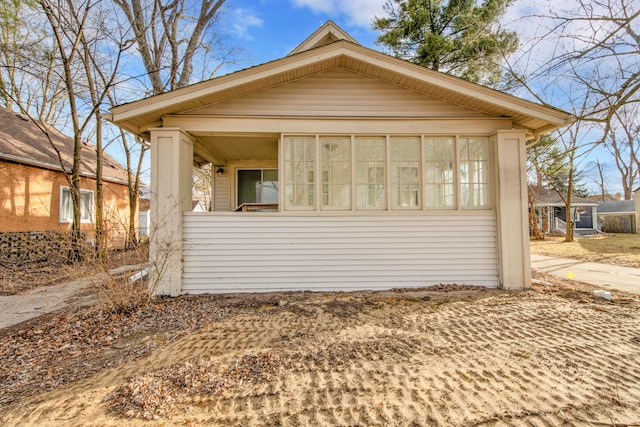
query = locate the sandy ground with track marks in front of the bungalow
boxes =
[0,286,640,426]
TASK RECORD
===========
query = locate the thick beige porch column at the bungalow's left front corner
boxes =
[149,128,194,296]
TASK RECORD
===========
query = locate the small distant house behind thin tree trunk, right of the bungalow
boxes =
[536,188,599,236]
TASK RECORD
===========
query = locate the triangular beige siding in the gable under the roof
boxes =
[187,68,484,117]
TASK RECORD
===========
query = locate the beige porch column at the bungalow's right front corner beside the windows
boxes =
[493,131,531,289]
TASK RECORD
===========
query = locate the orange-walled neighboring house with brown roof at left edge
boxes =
[0,108,129,251]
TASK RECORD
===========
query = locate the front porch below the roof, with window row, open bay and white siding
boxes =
[152,128,520,294]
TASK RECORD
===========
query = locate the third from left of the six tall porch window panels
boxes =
[355,137,386,209]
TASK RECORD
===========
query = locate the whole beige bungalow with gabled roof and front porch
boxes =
[111,21,572,295]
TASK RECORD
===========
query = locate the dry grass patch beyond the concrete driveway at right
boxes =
[530,234,640,268]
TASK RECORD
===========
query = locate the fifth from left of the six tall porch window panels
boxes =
[424,137,455,208]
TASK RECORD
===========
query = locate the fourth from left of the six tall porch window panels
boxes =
[390,137,420,209]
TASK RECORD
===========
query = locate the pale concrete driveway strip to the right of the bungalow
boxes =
[531,254,640,294]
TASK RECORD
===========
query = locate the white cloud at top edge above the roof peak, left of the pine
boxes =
[291,0,386,28]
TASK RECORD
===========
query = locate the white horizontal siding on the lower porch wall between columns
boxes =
[183,212,498,293]
